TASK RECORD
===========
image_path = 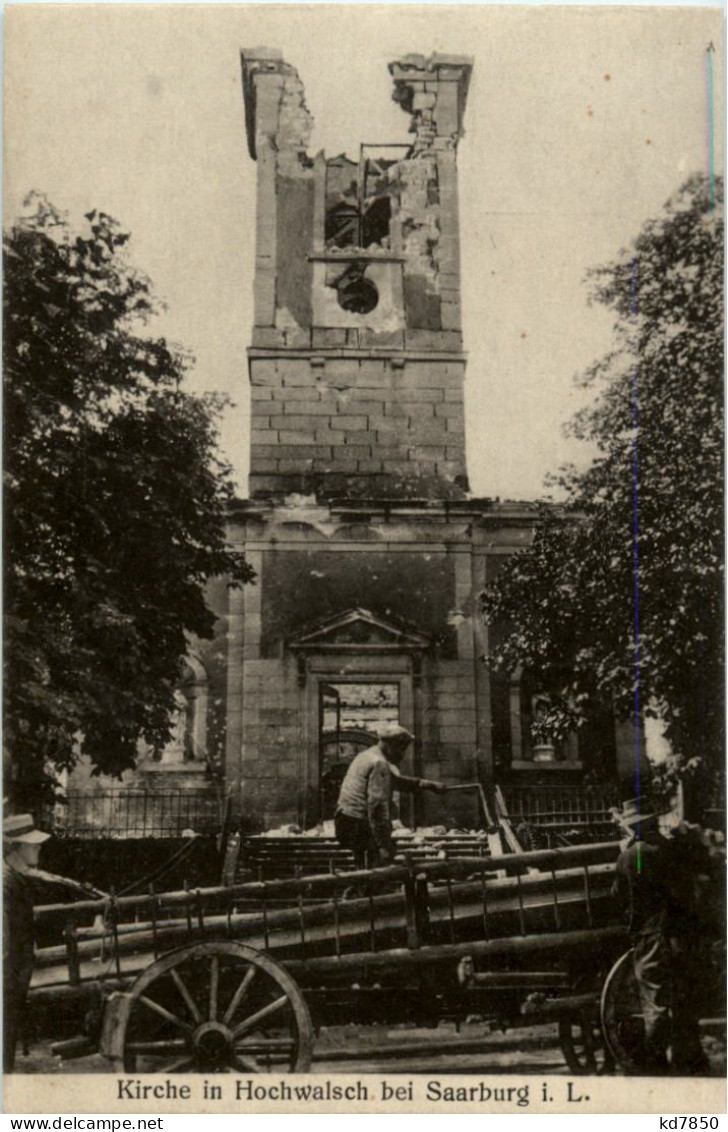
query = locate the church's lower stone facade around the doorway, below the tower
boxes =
[219,498,550,827]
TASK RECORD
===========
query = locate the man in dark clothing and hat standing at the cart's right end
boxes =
[614,799,720,1074]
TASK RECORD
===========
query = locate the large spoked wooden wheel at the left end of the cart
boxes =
[105,942,314,1073]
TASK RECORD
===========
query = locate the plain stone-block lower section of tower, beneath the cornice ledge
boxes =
[250,357,466,498]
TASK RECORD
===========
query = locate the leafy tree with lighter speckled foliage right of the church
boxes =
[483,169,723,805]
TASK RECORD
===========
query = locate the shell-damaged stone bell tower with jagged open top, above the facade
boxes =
[242,49,472,500]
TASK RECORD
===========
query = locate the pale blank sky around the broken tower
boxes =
[5,5,723,499]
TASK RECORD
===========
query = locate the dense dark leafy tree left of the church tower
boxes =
[3,196,252,804]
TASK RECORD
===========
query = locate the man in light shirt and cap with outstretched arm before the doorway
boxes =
[334,723,447,868]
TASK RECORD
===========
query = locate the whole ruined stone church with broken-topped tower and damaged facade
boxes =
[59,49,634,851]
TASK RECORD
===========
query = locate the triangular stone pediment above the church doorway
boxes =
[289,609,429,653]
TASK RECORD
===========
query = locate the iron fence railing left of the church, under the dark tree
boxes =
[44,789,222,840]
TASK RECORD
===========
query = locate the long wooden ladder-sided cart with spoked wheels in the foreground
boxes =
[29,842,625,1073]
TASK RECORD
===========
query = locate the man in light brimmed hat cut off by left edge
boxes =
[2,814,50,1073]
